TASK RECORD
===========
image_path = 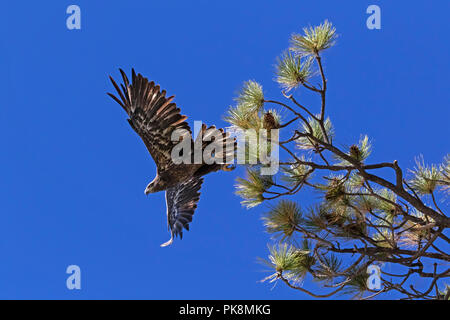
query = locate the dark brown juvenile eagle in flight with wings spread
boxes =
[108,69,236,247]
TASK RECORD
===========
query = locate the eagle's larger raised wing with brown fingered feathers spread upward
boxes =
[108,69,191,173]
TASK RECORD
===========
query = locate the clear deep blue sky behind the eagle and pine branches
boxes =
[0,0,450,299]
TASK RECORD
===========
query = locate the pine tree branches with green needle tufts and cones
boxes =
[226,21,450,300]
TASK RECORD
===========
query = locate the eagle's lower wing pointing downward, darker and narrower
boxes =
[161,177,203,247]
